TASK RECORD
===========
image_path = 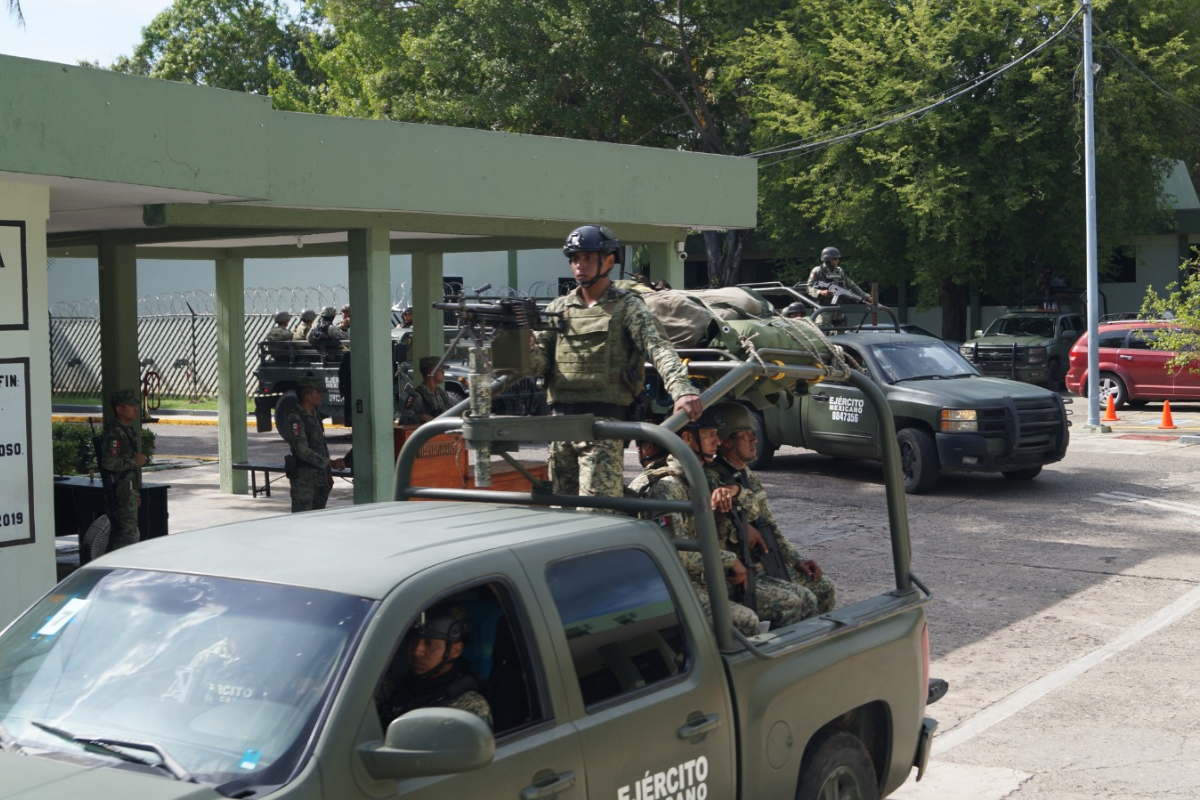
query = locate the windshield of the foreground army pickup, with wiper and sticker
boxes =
[0,570,372,784]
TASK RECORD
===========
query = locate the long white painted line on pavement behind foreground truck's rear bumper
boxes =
[932,587,1200,756]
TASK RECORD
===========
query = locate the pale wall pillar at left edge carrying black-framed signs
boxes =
[0,182,55,628]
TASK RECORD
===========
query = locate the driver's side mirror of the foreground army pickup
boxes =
[358,708,496,781]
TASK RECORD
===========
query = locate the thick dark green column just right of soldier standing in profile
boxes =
[348,228,393,504]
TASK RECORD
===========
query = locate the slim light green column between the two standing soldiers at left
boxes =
[216,258,247,494]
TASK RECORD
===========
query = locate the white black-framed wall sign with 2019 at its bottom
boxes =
[0,359,34,547]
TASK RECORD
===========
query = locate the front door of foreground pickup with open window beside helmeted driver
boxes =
[350,552,587,800]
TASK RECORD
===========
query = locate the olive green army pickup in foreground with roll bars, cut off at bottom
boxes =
[0,363,941,800]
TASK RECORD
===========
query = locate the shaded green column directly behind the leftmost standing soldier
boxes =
[98,237,141,420]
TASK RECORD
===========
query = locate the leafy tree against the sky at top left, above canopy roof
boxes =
[113,0,320,95]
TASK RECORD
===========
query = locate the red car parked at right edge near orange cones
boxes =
[1067,320,1200,408]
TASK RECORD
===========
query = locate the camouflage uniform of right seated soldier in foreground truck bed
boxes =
[704,457,838,619]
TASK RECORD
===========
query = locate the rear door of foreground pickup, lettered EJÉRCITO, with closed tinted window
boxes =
[530,537,737,800]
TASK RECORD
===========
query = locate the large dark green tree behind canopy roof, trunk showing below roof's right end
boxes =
[298,0,790,283]
